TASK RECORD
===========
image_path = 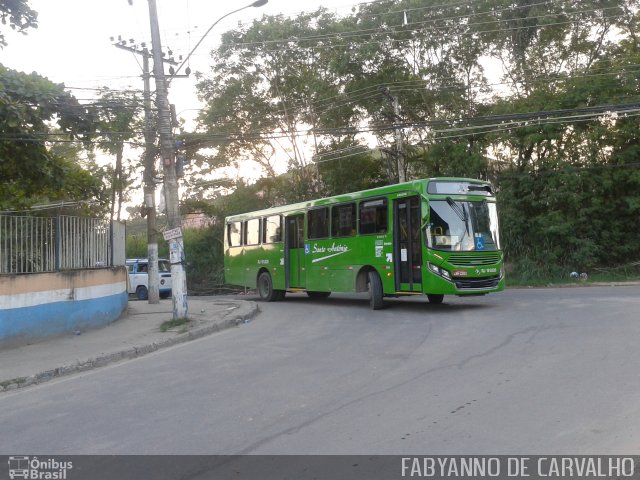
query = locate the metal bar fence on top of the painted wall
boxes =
[0,215,125,274]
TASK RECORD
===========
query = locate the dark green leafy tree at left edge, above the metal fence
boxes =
[0,65,101,209]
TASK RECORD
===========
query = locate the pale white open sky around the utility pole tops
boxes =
[0,0,361,127]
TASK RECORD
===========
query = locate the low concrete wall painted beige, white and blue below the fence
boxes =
[0,267,128,346]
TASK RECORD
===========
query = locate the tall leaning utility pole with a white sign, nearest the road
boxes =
[148,0,189,319]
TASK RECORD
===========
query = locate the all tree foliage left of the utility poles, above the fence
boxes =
[0,0,140,213]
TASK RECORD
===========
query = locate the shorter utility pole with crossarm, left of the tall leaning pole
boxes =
[114,42,178,303]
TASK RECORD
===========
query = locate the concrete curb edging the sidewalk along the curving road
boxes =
[0,300,259,393]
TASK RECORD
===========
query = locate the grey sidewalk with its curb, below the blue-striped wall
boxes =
[0,297,258,392]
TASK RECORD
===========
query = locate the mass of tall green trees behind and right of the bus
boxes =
[192,0,640,282]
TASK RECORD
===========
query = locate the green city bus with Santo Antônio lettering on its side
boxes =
[224,178,505,310]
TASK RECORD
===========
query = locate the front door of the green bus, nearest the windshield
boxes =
[393,196,422,292]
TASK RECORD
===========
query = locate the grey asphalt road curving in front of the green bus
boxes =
[0,287,640,455]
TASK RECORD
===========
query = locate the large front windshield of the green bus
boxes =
[425,197,500,252]
